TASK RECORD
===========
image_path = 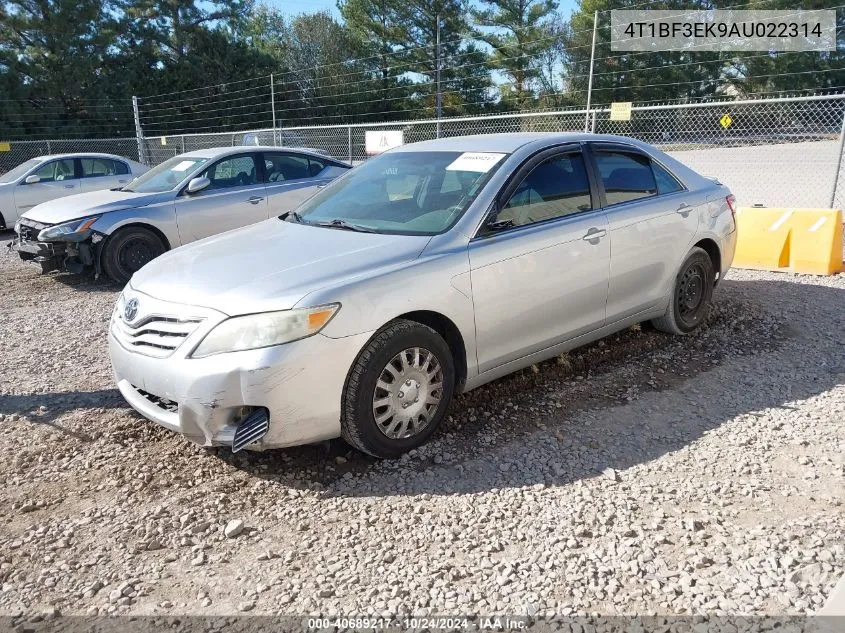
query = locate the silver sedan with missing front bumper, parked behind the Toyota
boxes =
[15,147,349,283]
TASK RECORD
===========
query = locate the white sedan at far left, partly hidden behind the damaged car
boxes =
[0,153,149,229]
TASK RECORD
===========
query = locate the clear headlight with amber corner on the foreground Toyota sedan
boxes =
[191,303,340,358]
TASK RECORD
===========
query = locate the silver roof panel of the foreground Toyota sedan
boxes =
[391,132,645,154]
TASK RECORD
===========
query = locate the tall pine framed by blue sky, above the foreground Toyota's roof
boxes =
[472,0,558,107]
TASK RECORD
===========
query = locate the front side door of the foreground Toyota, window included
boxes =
[469,149,610,372]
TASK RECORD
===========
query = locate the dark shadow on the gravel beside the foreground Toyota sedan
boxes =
[217,279,845,496]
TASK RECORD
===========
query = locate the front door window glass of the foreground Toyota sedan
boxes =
[496,153,592,226]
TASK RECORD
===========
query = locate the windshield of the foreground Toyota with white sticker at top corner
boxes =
[288,152,506,235]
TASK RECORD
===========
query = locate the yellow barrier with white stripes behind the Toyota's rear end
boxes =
[733,207,845,275]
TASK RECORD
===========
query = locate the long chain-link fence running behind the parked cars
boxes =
[0,95,845,207]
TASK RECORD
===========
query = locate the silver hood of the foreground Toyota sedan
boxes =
[130,218,431,316]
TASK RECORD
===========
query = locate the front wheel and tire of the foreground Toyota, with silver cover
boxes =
[340,319,455,458]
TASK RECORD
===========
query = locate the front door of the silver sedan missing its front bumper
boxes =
[171,152,268,244]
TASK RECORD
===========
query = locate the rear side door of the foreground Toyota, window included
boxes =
[588,143,705,323]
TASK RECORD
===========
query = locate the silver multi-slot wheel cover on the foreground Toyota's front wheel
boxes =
[373,347,443,440]
